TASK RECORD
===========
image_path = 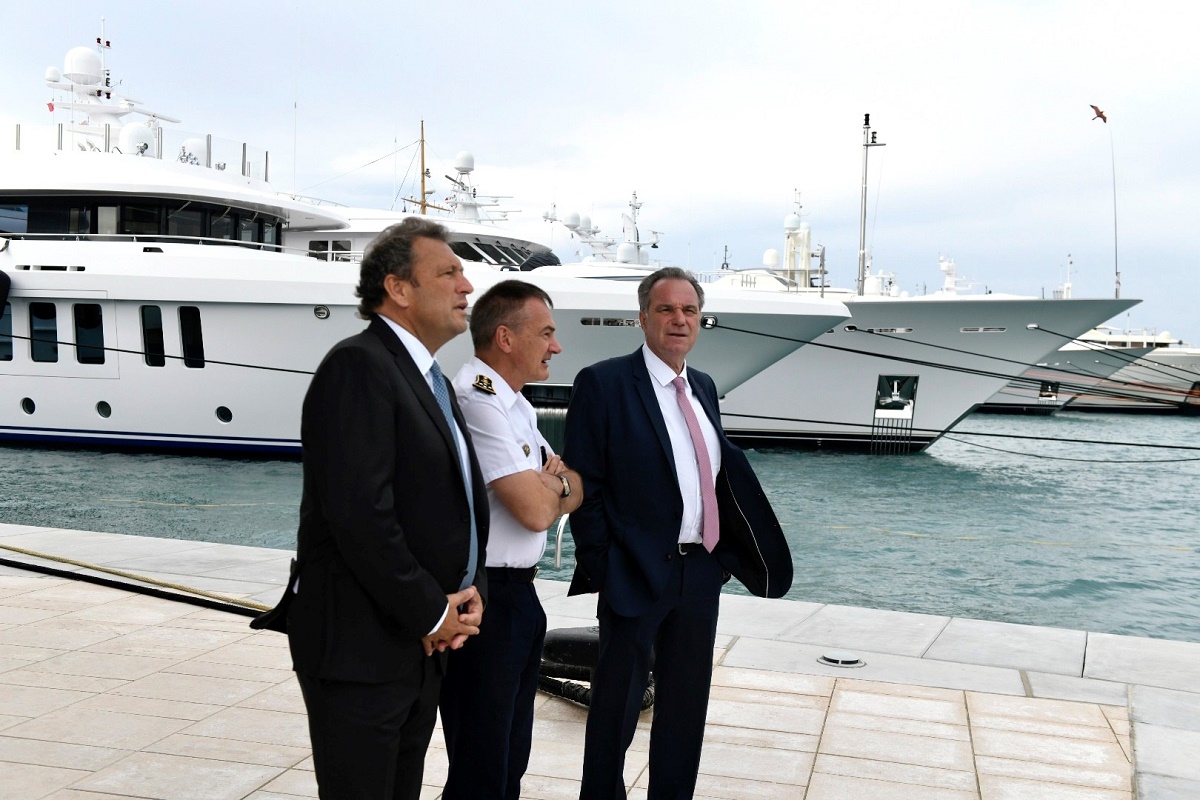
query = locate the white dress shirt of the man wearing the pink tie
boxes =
[648,344,721,548]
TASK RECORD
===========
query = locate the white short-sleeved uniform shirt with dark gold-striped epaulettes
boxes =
[454,357,554,569]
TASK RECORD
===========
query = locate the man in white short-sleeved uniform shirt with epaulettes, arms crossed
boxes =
[439,281,583,800]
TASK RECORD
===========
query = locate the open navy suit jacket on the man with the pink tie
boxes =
[563,348,792,616]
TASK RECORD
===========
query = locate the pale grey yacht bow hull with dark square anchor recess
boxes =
[721,295,1138,453]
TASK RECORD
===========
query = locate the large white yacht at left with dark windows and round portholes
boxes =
[0,38,848,455]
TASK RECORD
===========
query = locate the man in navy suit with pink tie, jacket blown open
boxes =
[563,267,791,800]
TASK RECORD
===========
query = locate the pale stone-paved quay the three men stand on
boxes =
[0,525,1200,800]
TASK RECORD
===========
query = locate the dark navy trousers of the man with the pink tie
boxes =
[580,548,721,800]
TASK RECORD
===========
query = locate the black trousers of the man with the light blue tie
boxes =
[296,658,442,800]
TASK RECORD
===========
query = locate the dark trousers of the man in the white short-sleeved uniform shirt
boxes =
[440,570,546,800]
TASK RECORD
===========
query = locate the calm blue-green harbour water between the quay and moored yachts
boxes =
[0,413,1200,642]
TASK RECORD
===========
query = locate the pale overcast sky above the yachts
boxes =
[0,0,1200,343]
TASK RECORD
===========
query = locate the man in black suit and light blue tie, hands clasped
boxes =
[287,218,488,800]
